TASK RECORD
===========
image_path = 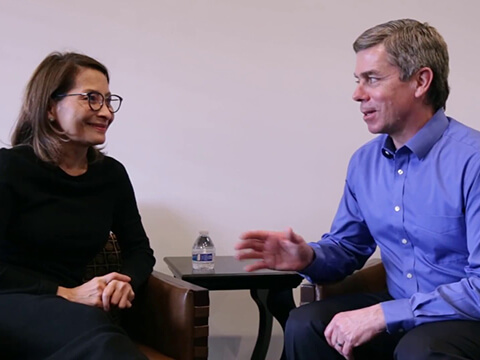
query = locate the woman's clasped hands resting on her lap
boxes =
[57,272,135,311]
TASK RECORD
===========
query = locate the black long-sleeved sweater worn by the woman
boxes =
[0,146,155,294]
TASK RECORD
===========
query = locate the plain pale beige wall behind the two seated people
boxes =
[0,0,480,359]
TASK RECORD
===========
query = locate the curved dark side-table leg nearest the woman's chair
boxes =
[250,289,273,360]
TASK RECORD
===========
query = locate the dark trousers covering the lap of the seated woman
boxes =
[0,294,146,360]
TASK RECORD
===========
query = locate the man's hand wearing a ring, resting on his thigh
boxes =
[324,304,386,360]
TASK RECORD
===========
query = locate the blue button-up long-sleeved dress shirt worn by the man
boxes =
[302,110,480,333]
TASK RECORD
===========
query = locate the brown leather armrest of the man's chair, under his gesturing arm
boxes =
[300,259,387,304]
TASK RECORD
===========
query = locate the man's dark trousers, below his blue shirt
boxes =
[285,292,480,360]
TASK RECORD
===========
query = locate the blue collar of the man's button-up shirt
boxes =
[382,109,448,159]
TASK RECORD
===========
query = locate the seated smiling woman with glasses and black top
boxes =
[0,53,155,360]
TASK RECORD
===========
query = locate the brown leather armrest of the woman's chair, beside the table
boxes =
[125,271,210,360]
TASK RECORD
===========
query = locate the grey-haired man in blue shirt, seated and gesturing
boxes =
[236,19,480,360]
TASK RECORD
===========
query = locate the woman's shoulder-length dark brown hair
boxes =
[11,52,110,165]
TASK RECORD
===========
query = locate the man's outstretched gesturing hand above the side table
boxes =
[235,228,314,271]
